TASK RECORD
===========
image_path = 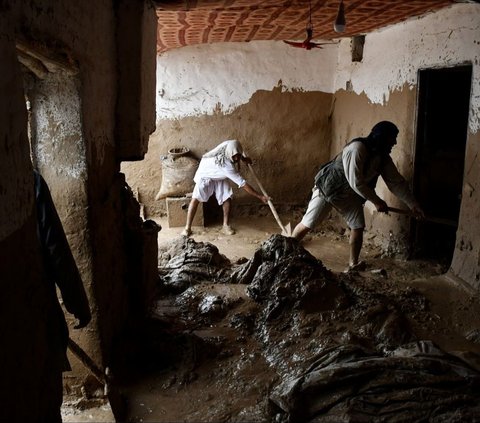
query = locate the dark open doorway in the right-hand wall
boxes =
[412,65,472,266]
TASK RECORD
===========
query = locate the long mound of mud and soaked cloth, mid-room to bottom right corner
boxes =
[160,235,480,422]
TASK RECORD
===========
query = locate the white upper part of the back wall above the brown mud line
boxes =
[157,41,338,119]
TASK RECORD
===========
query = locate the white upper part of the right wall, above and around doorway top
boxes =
[335,4,480,133]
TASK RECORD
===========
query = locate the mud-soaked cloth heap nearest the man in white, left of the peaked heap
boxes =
[158,237,231,293]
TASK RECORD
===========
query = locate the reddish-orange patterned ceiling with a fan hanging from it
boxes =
[153,0,460,53]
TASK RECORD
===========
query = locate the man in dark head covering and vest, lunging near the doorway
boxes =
[292,121,425,270]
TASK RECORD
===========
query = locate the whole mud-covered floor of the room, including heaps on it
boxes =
[62,216,480,423]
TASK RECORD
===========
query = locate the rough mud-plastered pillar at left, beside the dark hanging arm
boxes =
[15,2,127,384]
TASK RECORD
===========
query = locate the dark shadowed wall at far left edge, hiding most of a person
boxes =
[0,19,47,422]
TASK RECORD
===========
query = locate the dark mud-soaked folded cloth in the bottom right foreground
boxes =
[271,341,480,422]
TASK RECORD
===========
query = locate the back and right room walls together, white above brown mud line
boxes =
[122,4,480,287]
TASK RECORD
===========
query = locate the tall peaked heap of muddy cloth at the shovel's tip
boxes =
[232,234,347,318]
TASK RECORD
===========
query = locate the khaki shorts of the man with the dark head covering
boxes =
[302,188,365,229]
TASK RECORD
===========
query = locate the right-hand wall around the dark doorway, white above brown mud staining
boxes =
[332,4,480,289]
